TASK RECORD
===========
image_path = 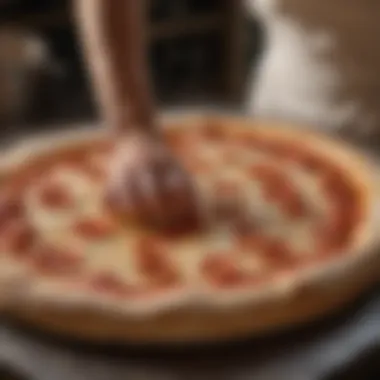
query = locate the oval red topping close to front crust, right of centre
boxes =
[201,254,248,288]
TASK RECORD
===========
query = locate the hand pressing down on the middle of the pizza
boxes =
[107,132,199,230]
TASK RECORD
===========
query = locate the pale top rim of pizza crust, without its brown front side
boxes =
[0,115,379,342]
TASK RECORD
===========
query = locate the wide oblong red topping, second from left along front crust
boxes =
[33,246,83,275]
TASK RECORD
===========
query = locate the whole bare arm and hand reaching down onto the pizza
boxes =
[74,0,197,227]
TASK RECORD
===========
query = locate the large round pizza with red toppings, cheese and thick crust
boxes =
[0,115,380,342]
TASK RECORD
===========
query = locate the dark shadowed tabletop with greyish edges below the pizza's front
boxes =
[0,289,380,380]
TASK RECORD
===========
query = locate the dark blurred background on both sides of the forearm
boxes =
[0,0,261,131]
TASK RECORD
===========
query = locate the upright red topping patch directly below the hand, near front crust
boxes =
[137,238,178,285]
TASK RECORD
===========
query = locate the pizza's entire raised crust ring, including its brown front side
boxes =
[0,115,380,342]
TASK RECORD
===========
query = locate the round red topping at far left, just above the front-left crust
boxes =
[3,221,36,257]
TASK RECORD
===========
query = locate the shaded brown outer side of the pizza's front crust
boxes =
[10,260,380,344]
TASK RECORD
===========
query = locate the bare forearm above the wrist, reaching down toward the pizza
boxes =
[74,0,154,132]
